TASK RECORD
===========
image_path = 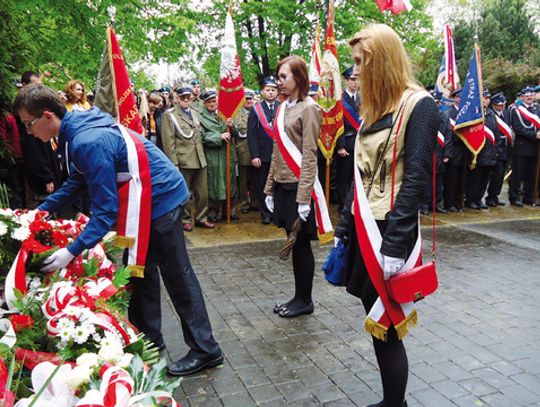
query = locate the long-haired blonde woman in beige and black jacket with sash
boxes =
[335,24,440,407]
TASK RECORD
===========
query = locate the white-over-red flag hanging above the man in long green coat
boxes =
[218,9,245,119]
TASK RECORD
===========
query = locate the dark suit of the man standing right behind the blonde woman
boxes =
[336,91,360,211]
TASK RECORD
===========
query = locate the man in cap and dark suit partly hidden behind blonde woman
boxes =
[336,66,360,212]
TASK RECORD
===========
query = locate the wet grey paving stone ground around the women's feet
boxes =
[159,220,540,407]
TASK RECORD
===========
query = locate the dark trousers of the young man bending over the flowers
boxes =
[128,206,221,356]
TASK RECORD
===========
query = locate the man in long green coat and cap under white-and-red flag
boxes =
[201,90,239,222]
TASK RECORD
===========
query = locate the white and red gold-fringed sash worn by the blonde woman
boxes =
[354,165,422,341]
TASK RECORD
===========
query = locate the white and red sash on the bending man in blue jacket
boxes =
[115,126,152,278]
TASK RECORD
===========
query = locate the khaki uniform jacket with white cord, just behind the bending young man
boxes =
[161,107,206,169]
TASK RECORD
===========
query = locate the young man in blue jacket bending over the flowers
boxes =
[15,84,223,376]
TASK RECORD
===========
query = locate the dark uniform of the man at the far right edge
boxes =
[510,104,540,204]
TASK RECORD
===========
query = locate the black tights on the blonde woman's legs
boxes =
[373,327,409,407]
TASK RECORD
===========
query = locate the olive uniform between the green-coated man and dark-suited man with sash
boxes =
[234,108,253,209]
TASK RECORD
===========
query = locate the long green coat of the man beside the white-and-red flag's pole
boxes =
[201,107,238,218]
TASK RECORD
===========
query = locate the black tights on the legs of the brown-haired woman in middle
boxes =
[287,233,315,306]
